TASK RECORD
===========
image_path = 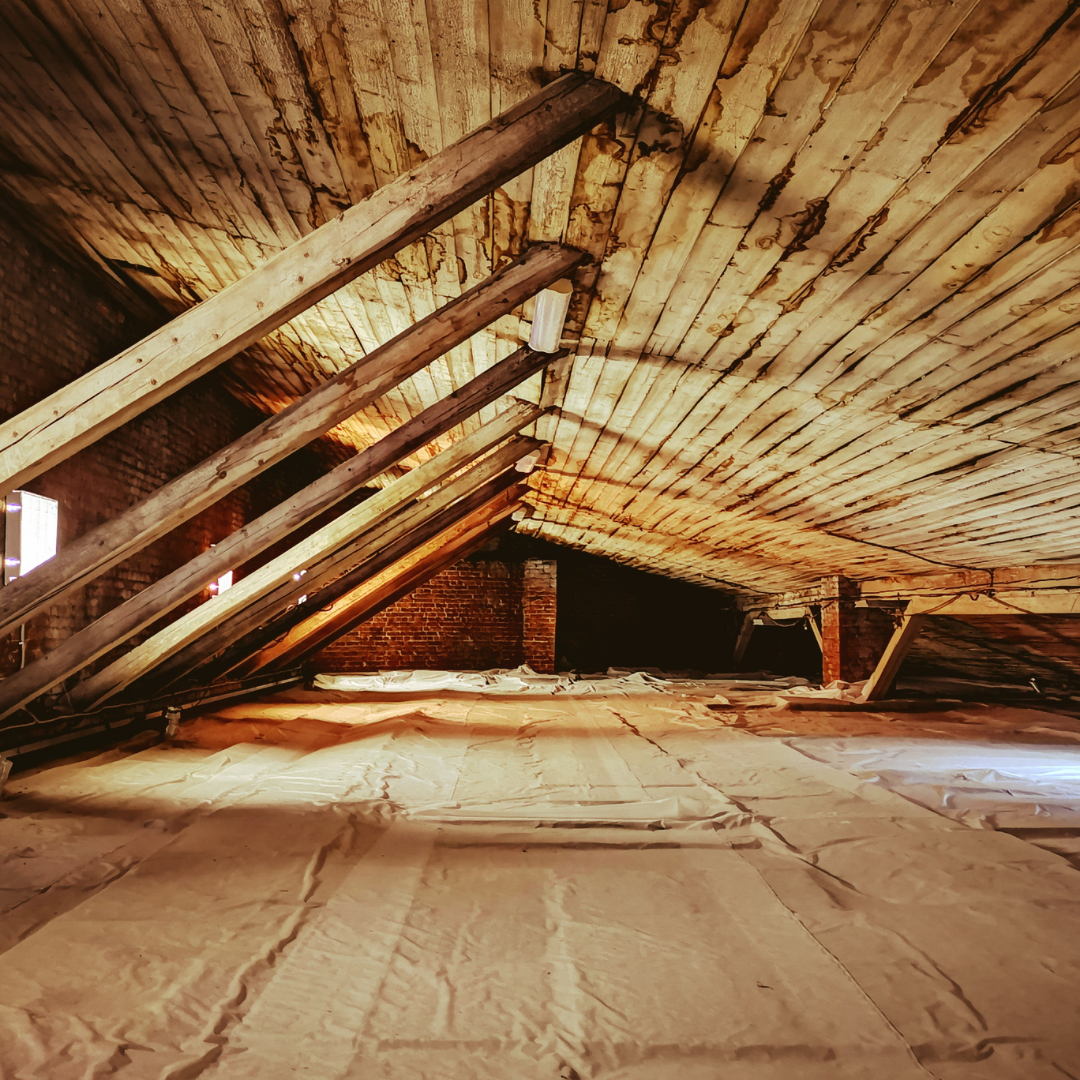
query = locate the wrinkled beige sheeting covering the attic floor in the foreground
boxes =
[0,691,1080,1080]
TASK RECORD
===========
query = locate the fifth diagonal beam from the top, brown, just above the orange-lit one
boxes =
[131,460,536,692]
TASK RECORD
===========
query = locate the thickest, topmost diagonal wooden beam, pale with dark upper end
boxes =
[0,72,627,490]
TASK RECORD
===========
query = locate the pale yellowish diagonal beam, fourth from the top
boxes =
[71,404,542,708]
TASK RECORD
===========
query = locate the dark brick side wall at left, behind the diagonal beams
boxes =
[0,210,321,674]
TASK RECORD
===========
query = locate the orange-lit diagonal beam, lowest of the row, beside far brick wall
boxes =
[243,484,527,675]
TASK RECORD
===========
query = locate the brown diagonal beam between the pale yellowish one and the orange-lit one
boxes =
[136,451,540,688]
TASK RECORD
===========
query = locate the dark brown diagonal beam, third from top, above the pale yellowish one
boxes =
[0,349,558,718]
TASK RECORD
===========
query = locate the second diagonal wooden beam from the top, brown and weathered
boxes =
[0,245,582,634]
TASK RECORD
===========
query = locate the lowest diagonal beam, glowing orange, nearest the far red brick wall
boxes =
[244,488,523,675]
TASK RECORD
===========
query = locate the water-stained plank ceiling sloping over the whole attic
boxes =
[0,0,1080,593]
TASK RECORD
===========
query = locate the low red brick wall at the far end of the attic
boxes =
[312,558,537,672]
